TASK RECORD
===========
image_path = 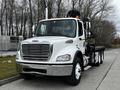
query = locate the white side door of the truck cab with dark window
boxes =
[78,21,85,54]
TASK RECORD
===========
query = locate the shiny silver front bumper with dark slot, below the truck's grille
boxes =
[17,63,73,76]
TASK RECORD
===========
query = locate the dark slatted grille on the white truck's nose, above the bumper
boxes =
[22,44,52,61]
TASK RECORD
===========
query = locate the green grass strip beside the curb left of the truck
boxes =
[0,56,18,80]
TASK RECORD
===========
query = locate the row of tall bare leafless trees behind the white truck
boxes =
[0,0,115,46]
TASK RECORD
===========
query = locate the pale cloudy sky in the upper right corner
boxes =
[109,0,120,33]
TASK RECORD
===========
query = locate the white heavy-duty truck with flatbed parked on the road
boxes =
[16,18,104,85]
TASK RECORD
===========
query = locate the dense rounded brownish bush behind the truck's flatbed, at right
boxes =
[95,20,116,47]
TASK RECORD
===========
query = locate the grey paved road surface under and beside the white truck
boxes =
[0,49,120,90]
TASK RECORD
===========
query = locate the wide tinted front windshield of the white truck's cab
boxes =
[36,19,76,38]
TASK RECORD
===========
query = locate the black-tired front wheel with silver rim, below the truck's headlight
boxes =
[67,58,82,86]
